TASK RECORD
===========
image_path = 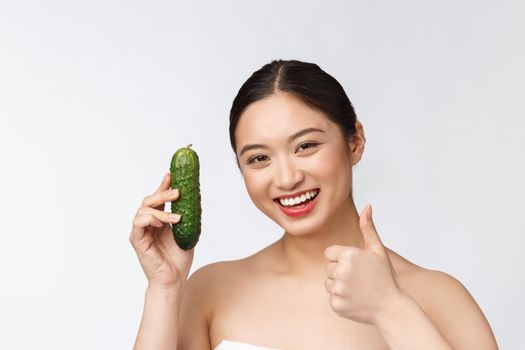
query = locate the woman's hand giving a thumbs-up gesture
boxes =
[325,205,404,324]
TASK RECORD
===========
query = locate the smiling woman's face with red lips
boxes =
[235,93,363,235]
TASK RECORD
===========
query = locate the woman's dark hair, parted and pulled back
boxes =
[230,60,357,167]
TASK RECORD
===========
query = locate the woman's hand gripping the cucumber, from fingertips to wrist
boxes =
[129,173,195,288]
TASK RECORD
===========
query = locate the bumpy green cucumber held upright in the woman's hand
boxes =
[170,144,202,250]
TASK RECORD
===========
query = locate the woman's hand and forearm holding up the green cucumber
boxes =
[129,173,194,350]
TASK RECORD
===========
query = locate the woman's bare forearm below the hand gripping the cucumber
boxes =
[133,286,182,350]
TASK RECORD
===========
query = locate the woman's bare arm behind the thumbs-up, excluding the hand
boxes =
[376,270,498,350]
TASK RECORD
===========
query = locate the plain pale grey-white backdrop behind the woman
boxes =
[0,0,525,349]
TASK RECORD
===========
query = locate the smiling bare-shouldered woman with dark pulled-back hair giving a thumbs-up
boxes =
[130,60,497,350]
